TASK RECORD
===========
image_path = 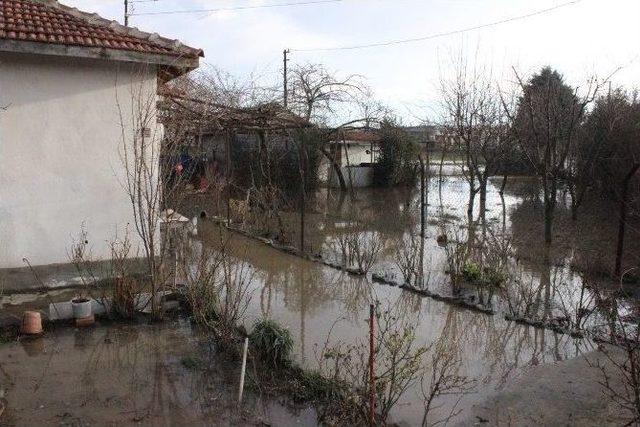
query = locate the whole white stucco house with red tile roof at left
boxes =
[0,0,203,289]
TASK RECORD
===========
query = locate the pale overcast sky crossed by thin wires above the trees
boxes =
[62,0,640,122]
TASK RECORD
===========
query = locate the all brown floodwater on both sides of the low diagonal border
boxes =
[185,164,639,425]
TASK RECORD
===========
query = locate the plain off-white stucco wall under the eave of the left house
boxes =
[0,53,156,276]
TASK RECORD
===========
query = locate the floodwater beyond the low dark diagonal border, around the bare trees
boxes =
[189,171,640,327]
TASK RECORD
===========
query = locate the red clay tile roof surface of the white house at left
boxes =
[0,0,204,58]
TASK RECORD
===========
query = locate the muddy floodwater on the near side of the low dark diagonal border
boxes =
[199,222,594,425]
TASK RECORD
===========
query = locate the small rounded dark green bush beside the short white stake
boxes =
[249,319,293,366]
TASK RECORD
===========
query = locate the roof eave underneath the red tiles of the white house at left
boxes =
[0,39,200,74]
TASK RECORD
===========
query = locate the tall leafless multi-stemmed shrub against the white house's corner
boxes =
[116,69,195,317]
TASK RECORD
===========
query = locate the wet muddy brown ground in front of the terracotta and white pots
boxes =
[0,319,316,426]
